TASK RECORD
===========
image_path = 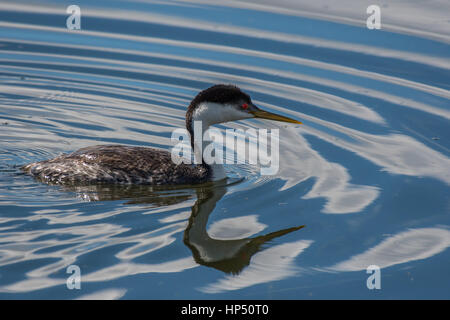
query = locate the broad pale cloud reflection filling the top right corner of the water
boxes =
[180,0,450,42]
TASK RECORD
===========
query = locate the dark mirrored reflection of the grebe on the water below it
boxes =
[54,179,304,274]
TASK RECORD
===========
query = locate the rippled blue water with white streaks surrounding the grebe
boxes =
[0,1,450,299]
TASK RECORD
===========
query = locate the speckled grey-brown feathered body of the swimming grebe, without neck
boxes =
[22,145,210,185]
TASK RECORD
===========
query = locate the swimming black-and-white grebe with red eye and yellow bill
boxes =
[22,85,300,185]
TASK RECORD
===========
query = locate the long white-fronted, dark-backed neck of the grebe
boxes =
[187,118,226,181]
